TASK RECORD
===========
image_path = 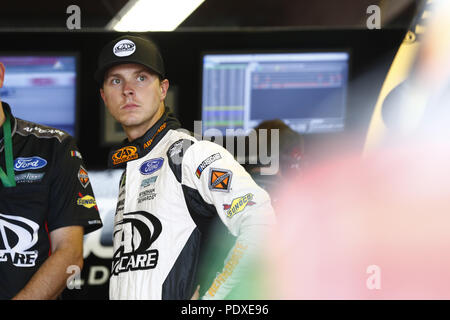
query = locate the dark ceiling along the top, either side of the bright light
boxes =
[0,0,420,31]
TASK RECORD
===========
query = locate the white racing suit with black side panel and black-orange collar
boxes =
[110,110,275,299]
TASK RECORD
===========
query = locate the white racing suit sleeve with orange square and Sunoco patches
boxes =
[182,141,275,299]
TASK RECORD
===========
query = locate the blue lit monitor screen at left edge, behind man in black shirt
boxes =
[0,53,77,136]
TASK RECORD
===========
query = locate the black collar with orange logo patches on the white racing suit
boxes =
[108,107,181,168]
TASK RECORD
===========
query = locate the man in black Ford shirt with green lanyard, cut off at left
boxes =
[0,63,102,300]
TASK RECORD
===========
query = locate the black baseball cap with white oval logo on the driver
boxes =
[94,35,165,84]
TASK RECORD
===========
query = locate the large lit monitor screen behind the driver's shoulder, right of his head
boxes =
[202,51,350,136]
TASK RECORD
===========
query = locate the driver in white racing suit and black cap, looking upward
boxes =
[95,36,274,299]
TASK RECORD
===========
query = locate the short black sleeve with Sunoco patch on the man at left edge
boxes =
[48,136,102,234]
